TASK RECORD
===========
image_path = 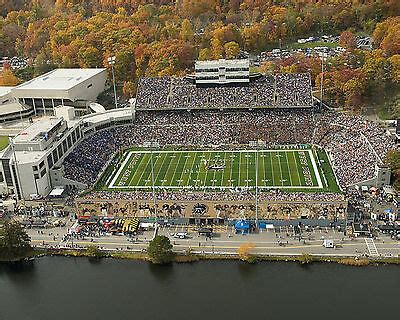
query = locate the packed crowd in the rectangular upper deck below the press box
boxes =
[136,74,312,109]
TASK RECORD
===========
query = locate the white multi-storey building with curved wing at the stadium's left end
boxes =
[0,106,132,200]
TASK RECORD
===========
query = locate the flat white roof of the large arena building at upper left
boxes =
[14,68,106,90]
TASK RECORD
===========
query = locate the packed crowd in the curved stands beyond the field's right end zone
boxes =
[314,111,395,187]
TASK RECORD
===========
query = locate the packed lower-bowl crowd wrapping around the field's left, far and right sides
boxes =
[64,109,395,192]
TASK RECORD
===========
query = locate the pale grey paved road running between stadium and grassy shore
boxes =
[28,226,400,257]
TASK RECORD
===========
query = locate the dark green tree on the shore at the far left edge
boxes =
[0,221,31,259]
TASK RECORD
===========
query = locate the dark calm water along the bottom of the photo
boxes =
[0,257,400,320]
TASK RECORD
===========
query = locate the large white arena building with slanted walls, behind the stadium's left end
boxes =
[11,68,107,115]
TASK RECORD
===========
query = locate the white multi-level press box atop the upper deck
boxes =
[195,59,250,85]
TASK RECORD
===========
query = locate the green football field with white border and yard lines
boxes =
[106,149,324,190]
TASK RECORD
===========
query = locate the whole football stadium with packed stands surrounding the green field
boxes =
[3,60,394,223]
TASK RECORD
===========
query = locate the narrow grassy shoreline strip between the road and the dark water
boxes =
[0,249,400,267]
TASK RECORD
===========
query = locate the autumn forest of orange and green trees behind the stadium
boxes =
[0,0,400,116]
